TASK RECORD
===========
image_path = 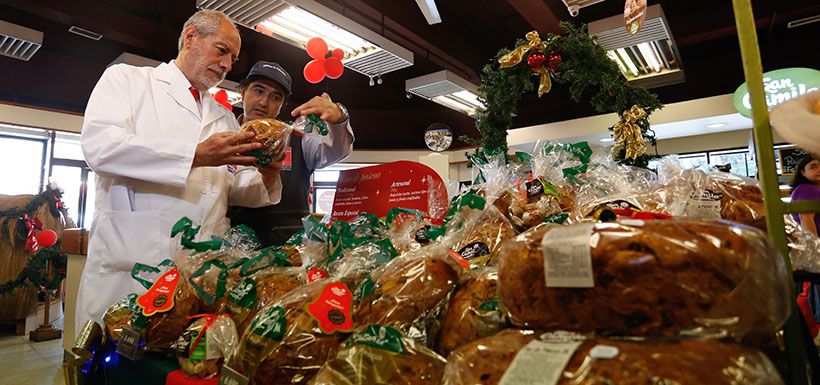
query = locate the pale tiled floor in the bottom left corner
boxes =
[0,329,64,385]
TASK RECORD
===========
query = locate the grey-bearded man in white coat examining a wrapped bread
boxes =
[76,10,281,328]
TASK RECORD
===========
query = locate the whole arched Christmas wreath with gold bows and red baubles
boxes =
[462,22,663,167]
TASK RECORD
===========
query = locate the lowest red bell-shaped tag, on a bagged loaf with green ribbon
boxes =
[307,282,353,334]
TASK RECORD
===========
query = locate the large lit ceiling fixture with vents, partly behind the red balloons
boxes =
[197,0,413,80]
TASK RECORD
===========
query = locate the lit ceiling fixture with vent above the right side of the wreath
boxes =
[589,4,686,88]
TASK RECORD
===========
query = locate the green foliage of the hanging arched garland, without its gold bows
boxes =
[460,22,663,167]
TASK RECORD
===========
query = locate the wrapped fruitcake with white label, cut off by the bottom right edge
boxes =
[443,329,783,385]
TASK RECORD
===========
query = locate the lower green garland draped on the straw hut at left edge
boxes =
[0,242,67,295]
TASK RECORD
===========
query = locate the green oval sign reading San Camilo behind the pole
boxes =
[732,68,820,118]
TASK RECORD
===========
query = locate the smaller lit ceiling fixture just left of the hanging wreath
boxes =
[404,70,484,116]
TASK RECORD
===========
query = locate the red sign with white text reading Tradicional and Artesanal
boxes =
[331,161,448,224]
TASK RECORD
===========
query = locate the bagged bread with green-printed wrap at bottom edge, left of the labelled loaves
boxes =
[310,325,447,385]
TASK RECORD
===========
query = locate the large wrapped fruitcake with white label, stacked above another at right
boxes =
[498,220,788,338]
